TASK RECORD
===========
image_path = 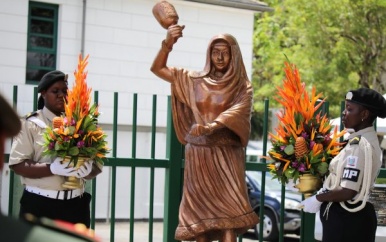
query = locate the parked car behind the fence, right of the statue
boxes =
[246,171,302,241]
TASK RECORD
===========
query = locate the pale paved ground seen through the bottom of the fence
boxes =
[95,222,299,242]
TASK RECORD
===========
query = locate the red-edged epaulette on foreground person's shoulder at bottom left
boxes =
[25,214,99,242]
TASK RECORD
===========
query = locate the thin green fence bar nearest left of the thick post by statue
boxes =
[148,95,157,242]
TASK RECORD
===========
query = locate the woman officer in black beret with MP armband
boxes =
[302,88,386,242]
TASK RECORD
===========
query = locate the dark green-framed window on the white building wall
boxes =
[26,2,58,84]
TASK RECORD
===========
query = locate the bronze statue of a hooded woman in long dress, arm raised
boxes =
[151,2,259,242]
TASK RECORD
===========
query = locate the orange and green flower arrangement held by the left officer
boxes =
[43,55,109,166]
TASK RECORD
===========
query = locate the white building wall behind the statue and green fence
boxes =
[0,0,254,218]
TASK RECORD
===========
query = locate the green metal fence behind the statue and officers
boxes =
[5,86,386,242]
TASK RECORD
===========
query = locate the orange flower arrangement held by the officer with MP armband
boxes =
[268,62,345,184]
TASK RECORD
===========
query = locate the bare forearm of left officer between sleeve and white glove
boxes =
[9,160,53,179]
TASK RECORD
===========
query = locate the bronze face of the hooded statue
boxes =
[210,41,231,73]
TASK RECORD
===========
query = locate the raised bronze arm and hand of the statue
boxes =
[150,24,185,82]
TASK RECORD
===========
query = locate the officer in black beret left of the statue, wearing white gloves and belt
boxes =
[9,70,101,227]
